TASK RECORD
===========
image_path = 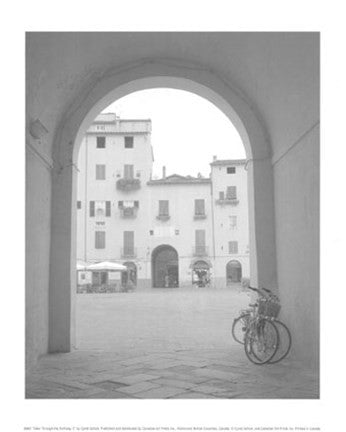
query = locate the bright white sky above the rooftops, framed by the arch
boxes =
[103,88,245,177]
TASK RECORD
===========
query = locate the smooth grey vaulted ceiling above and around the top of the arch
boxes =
[26,33,319,160]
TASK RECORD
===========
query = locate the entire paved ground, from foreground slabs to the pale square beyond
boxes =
[26,289,319,399]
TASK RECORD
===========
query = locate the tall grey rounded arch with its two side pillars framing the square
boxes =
[49,59,277,352]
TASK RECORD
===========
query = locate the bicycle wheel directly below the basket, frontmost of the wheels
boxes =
[244,318,280,365]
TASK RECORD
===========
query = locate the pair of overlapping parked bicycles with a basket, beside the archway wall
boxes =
[232,286,292,364]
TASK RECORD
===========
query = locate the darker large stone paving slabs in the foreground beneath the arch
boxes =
[26,345,318,399]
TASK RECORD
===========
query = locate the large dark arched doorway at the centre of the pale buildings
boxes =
[151,245,179,288]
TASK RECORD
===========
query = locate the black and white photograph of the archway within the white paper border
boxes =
[26,32,319,399]
